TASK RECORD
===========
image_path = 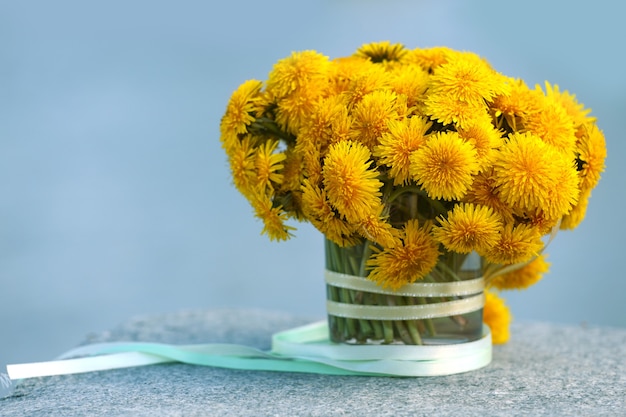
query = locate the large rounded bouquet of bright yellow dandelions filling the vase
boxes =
[220,42,606,344]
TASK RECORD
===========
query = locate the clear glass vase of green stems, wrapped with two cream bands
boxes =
[325,239,484,345]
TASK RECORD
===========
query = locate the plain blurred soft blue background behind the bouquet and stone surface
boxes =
[0,0,626,369]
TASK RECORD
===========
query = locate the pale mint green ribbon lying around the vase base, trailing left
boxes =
[7,322,492,380]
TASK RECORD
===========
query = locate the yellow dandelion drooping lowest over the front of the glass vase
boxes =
[367,220,439,289]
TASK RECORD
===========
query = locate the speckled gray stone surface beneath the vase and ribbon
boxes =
[0,310,626,417]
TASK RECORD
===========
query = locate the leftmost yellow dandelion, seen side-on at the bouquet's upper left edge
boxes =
[220,80,263,151]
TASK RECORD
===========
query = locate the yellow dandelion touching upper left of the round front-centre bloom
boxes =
[374,116,432,185]
